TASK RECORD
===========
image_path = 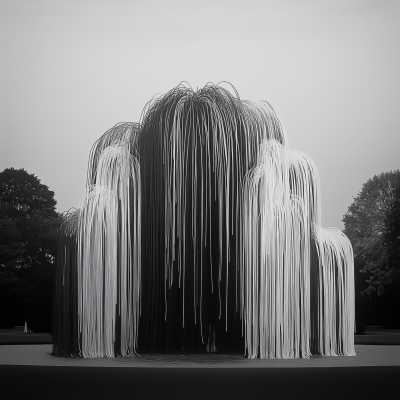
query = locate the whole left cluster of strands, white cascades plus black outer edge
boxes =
[53,124,141,357]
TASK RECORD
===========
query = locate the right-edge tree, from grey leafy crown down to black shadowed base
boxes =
[343,170,400,330]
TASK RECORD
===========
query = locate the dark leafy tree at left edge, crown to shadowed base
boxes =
[0,168,60,332]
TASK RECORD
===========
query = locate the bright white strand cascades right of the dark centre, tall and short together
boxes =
[240,140,354,358]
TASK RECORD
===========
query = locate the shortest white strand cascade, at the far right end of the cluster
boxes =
[313,226,355,356]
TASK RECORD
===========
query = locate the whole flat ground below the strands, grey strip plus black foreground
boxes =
[0,331,400,400]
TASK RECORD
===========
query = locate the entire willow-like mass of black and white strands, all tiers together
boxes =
[53,85,355,358]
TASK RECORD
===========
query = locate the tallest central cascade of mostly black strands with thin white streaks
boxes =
[138,85,286,352]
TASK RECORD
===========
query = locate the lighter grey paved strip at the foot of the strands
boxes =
[0,344,400,368]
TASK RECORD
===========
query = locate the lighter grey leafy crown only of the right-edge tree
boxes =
[343,170,400,295]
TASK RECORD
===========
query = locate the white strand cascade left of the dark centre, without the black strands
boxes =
[77,145,141,357]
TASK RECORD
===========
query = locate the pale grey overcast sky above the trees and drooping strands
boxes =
[0,0,400,229]
